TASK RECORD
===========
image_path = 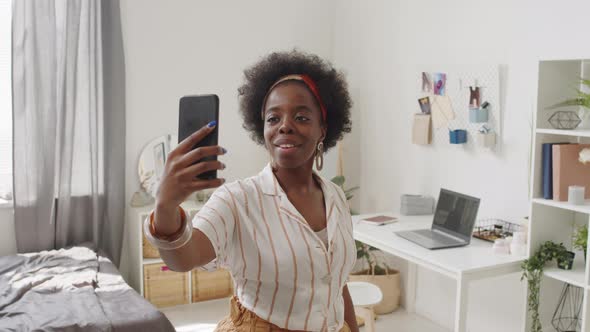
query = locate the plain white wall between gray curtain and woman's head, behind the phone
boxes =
[121,0,342,273]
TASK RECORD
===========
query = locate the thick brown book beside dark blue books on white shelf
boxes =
[552,144,590,202]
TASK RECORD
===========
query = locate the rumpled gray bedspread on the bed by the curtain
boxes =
[0,247,174,332]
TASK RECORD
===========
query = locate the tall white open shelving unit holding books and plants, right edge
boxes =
[524,59,590,332]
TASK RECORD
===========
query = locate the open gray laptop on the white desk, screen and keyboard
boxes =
[395,189,480,249]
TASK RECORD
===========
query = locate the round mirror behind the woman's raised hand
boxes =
[137,134,178,197]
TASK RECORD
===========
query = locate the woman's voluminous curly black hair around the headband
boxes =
[238,50,352,151]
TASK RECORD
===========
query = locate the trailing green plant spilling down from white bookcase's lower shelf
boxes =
[520,241,573,332]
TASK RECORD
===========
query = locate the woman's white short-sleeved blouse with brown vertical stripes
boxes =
[192,165,356,331]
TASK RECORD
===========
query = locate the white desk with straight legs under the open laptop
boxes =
[352,213,526,332]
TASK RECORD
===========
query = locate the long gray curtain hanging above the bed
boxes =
[12,0,125,265]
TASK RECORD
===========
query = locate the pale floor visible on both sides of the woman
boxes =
[161,299,445,332]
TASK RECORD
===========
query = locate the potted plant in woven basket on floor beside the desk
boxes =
[332,175,401,315]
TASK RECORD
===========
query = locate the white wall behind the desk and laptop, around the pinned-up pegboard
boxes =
[333,0,590,332]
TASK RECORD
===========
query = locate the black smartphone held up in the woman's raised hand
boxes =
[178,95,219,180]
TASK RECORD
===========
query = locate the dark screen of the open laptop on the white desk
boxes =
[432,189,479,240]
